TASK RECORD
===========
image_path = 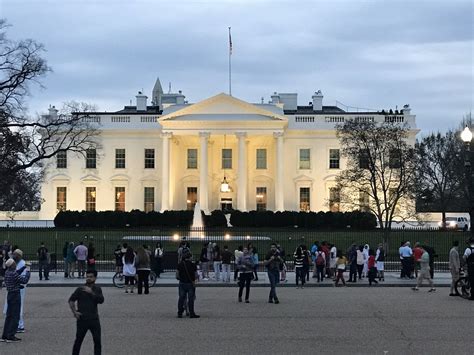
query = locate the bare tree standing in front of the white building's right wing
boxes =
[336,120,416,230]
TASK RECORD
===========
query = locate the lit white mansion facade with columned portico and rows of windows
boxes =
[40,80,418,219]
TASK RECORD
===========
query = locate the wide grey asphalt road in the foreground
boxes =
[0,287,474,355]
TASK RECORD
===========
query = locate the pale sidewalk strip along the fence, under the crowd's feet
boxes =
[23,271,451,287]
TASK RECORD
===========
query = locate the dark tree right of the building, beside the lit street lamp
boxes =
[415,131,464,227]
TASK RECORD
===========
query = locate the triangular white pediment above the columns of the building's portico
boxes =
[159,93,287,121]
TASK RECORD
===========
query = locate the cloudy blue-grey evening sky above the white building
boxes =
[0,0,474,134]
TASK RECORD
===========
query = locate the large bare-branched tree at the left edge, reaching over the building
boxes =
[0,19,98,211]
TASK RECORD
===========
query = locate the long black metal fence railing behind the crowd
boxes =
[0,228,470,271]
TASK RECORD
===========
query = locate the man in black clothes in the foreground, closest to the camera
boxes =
[69,270,104,355]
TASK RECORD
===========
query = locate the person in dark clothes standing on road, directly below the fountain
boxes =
[177,248,200,318]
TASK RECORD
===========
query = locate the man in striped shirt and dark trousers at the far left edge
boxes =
[1,258,30,342]
